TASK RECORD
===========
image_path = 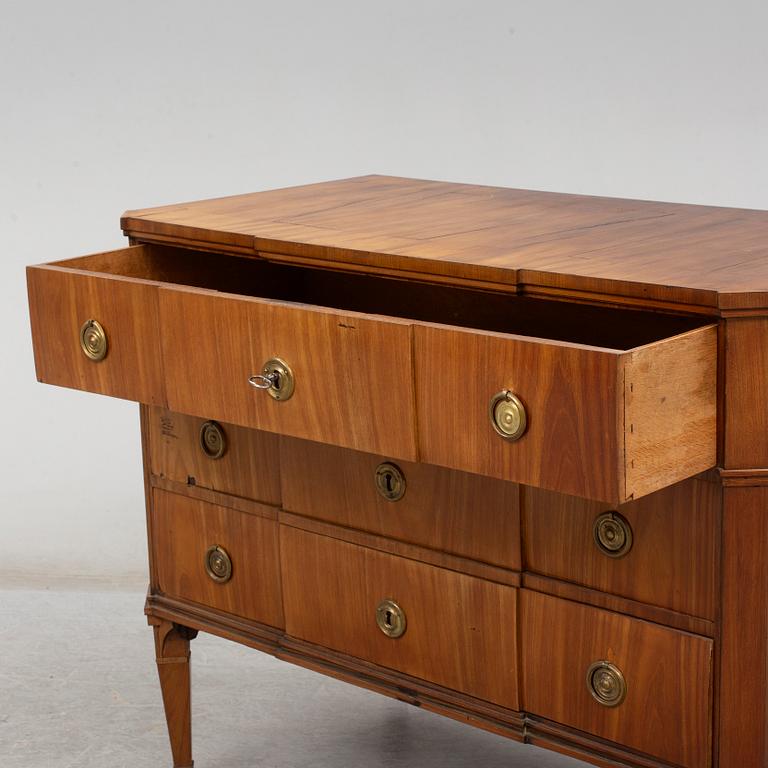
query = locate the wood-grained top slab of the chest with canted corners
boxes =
[122,176,768,310]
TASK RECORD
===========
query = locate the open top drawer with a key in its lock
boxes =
[28,245,717,503]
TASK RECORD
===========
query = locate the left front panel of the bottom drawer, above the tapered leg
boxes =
[151,488,284,628]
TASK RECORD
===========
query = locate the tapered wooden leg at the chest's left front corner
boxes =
[149,617,197,768]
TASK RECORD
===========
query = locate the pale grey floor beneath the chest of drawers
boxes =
[0,588,585,768]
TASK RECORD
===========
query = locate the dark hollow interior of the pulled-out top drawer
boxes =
[56,245,711,350]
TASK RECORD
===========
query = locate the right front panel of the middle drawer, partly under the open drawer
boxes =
[522,478,721,621]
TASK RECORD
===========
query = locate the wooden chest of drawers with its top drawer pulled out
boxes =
[28,177,768,768]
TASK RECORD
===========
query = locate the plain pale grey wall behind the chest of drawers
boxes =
[0,0,768,583]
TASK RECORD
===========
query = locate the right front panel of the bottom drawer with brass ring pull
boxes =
[520,590,712,768]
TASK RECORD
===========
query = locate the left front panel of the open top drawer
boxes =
[27,255,165,404]
